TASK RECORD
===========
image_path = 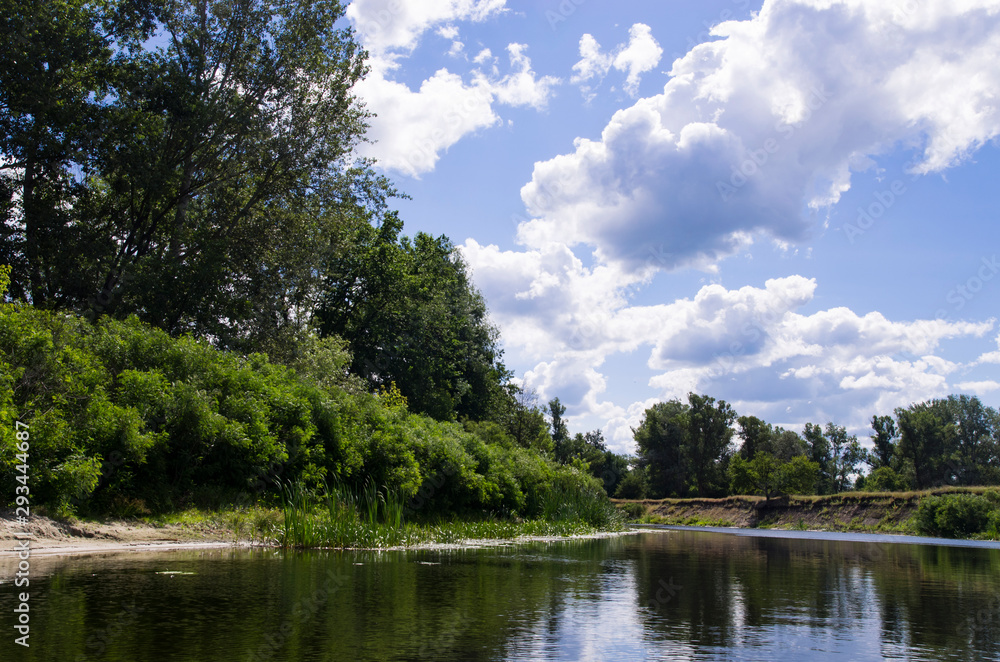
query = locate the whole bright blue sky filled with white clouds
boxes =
[348,0,1000,451]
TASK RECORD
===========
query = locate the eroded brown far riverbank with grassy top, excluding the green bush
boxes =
[613,487,996,535]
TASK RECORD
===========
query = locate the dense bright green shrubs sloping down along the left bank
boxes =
[0,306,608,522]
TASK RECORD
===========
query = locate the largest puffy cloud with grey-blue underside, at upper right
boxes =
[518,0,1000,272]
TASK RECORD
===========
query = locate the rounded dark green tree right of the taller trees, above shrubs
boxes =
[315,231,515,422]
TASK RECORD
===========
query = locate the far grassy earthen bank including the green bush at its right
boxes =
[615,487,1000,540]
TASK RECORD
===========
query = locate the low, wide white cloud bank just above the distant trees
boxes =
[463,240,995,450]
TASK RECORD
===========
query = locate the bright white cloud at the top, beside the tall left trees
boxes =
[347,0,559,177]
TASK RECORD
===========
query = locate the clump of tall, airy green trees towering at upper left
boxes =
[0,0,376,351]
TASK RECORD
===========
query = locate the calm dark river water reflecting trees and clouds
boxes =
[0,530,1000,662]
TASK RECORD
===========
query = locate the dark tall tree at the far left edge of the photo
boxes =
[0,0,129,304]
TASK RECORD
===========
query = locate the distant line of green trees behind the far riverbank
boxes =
[615,393,1000,498]
